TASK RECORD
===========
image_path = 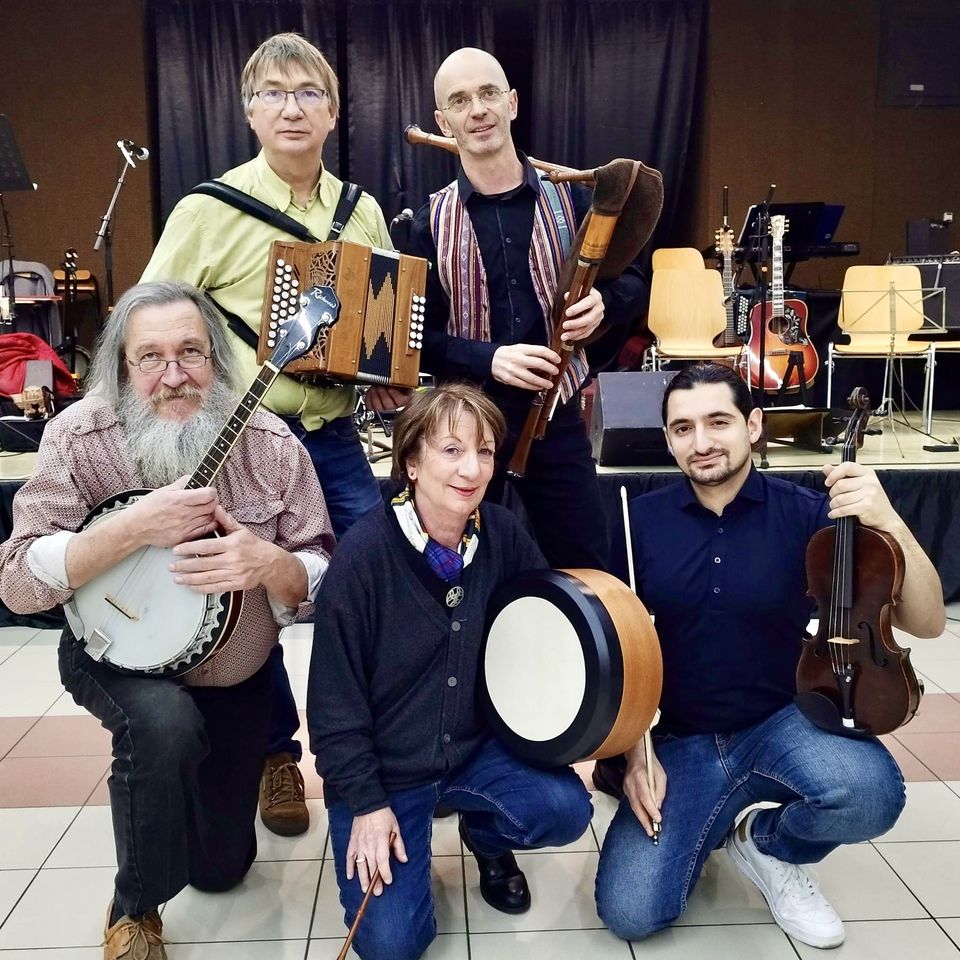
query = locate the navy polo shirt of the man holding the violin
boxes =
[613,469,832,736]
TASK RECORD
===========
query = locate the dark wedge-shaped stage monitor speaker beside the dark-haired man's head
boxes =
[590,372,676,467]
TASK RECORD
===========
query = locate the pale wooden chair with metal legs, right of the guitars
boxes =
[827,263,934,429]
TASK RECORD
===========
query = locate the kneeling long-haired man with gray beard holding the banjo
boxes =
[0,282,333,960]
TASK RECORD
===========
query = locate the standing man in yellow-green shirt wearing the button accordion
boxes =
[142,33,392,835]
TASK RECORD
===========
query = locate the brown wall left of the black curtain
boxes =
[0,0,153,340]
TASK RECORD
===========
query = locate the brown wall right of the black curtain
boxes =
[686,0,960,287]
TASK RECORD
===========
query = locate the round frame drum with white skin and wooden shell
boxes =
[478,570,663,766]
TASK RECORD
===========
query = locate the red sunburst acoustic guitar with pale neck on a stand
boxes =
[739,215,820,393]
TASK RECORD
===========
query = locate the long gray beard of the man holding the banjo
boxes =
[117,379,238,487]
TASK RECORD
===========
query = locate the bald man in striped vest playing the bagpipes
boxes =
[411,47,647,568]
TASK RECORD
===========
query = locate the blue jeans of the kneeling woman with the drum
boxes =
[329,740,593,960]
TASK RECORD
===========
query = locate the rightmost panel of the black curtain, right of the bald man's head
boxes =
[531,0,707,256]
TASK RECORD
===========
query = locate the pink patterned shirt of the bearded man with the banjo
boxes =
[0,396,334,687]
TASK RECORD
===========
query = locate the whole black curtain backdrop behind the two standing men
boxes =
[147,0,706,232]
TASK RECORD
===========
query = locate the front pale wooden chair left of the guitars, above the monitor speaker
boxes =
[647,268,742,370]
